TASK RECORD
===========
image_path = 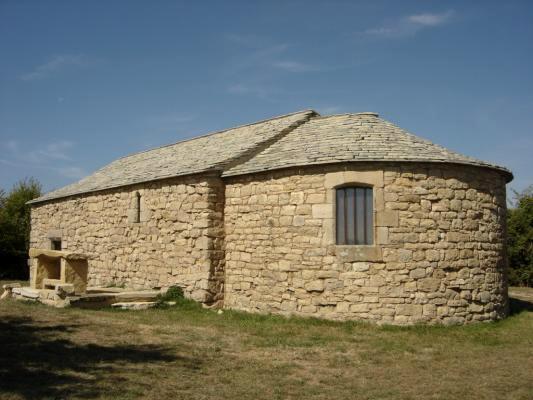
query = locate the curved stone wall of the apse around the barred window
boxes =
[224,163,508,324]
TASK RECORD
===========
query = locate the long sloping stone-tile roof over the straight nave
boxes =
[30,110,317,203]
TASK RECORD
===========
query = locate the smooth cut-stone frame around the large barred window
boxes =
[321,170,399,262]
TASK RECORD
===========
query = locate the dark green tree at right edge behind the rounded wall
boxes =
[507,185,533,286]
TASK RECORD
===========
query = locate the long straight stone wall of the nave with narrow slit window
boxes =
[31,176,224,302]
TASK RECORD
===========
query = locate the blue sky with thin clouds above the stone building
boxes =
[0,0,533,197]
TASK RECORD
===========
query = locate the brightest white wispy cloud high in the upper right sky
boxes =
[363,10,454,38]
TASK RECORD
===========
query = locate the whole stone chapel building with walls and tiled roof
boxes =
[31,111,512,324]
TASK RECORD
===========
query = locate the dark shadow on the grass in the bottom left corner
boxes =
[0,317,201,399]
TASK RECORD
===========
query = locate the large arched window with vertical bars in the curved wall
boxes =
[335,186,374,245]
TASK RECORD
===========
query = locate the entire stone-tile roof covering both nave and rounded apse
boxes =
[30,110,513,203]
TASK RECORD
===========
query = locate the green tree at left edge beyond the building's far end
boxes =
[0,178,41,278]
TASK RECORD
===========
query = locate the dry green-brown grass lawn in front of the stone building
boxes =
[0,282,533,400]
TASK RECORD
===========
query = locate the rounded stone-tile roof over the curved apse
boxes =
[222,113,512,180]
